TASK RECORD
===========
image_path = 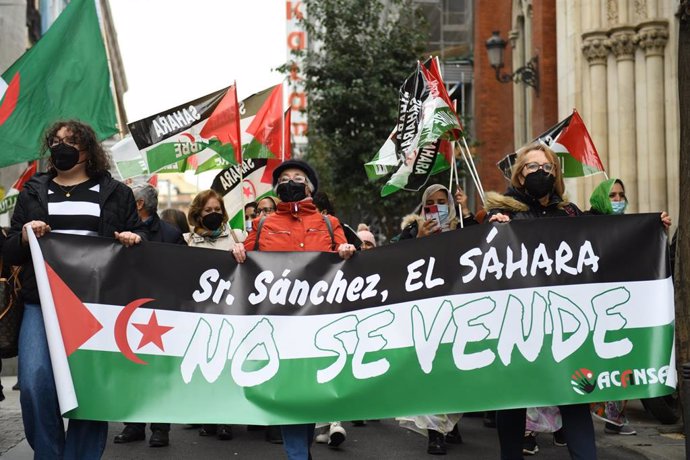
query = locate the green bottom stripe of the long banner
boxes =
[67,324,673,425]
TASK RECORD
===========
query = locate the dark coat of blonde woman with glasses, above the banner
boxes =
[484,187,582,220]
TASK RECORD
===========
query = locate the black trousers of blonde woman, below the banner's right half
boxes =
[496,404,597,460]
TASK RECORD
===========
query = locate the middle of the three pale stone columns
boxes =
[609,29,638,212]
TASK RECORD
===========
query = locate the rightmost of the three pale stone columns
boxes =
[635,21,668,211]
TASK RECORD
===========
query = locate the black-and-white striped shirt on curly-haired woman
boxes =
[48,179,101,236]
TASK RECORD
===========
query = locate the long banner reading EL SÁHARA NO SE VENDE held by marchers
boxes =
[29,214,676,425]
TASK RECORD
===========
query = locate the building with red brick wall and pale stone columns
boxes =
[475,0,679,220]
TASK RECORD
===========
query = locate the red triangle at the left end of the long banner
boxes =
[46,263,103,356]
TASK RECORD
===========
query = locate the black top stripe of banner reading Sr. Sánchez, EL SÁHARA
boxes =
[39,214,670,315]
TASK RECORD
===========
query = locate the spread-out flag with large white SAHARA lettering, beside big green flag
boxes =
[129,85,241,173]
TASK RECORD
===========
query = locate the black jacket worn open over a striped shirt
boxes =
[2,173,146,303]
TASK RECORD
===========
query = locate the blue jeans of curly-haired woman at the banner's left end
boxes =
[19,304,108,460]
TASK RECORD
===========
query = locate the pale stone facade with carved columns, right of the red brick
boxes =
[556,0,680,220]
